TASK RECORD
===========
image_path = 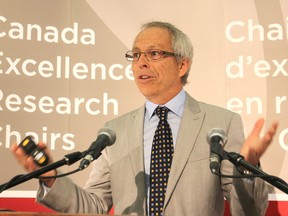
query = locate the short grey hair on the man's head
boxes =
[141,21,193,86]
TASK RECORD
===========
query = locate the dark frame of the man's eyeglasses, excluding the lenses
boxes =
[125,49,177,62]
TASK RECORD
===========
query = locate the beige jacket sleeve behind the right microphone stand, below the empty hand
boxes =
[221,114,268,216]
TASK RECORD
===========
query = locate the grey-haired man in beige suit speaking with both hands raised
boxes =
[12,22,277,216]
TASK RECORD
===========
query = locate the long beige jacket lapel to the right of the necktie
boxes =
[164,94,205,208]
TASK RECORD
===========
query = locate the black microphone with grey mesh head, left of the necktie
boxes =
[79,127,116,170]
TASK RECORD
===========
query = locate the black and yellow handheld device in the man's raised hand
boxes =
[19,136,49,166]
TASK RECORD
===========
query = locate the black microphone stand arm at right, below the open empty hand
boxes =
[223,151,288,194]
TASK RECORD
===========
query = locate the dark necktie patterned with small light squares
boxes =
[150,106,174,215]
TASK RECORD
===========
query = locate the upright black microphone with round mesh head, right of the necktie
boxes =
[207,128,227,174]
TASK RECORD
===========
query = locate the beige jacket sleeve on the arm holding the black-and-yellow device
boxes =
[36,150,112,214]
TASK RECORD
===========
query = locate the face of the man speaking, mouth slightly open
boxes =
[132,27,187,104]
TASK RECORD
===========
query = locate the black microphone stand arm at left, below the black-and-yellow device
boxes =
[0,152,85,193]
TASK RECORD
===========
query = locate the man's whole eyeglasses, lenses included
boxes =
[125,49,176,62]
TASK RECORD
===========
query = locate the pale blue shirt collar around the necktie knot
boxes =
[145,88,186,119]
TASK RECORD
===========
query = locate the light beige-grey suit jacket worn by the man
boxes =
[37,94,268,216]
